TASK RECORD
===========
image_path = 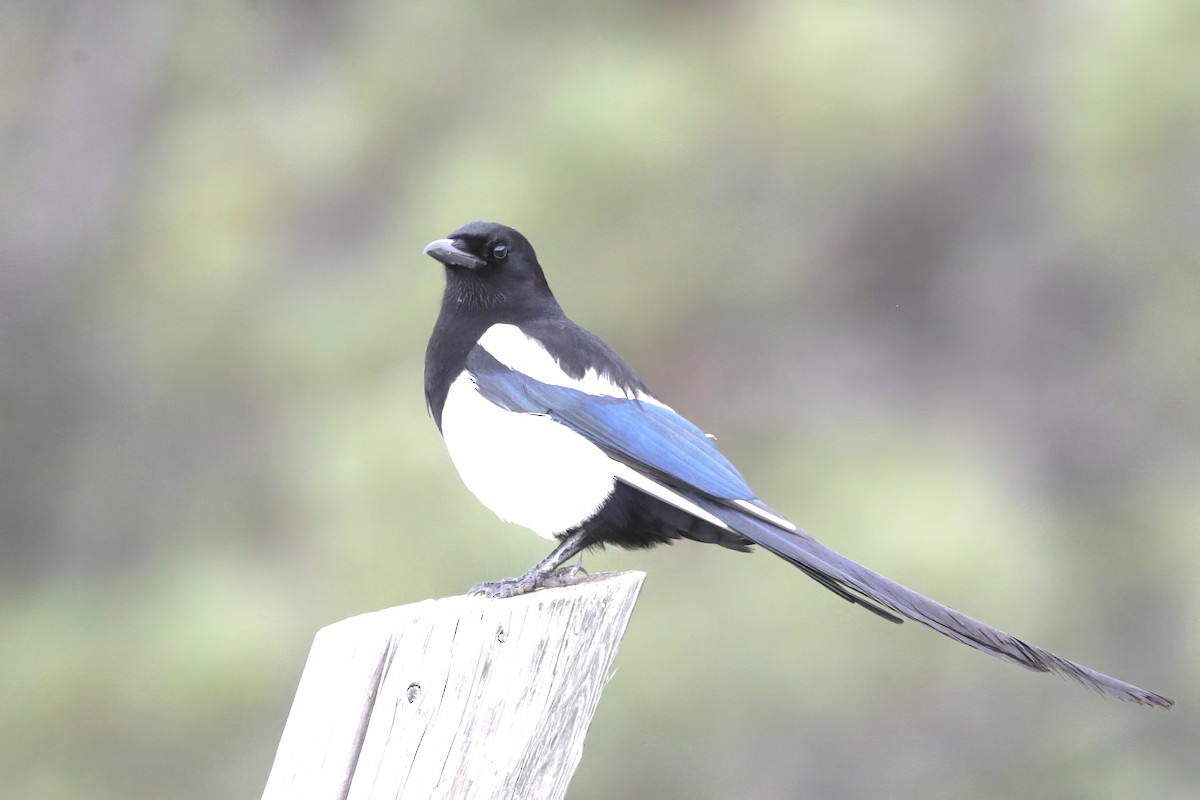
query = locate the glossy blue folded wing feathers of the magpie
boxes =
[467,347,755,500]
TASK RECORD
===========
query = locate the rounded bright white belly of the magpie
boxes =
[442,372,620,539]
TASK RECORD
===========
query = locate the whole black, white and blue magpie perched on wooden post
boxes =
[425,222,1175,709]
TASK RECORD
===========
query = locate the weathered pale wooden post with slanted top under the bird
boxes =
[263,572,646,800]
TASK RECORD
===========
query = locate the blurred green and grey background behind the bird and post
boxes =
[0,0,1200,800]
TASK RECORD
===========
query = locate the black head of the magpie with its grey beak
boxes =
[425,222,554,316]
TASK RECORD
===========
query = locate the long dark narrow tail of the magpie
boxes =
[698,499,1175,709]
